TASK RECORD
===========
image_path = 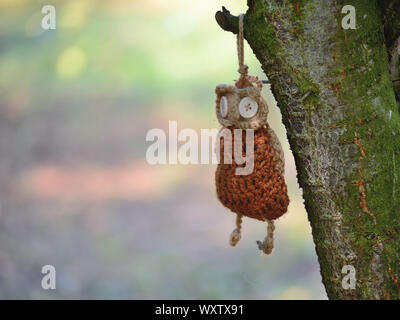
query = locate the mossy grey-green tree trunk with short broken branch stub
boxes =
[216,0,400,299]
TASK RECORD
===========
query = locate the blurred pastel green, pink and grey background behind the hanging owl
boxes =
[0,0,326,299]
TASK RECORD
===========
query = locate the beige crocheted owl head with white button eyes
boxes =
[215,84,268,130]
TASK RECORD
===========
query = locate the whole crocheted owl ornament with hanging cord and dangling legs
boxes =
[215,15,289,254]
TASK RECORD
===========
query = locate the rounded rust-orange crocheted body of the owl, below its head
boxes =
[215,124,289,221]
